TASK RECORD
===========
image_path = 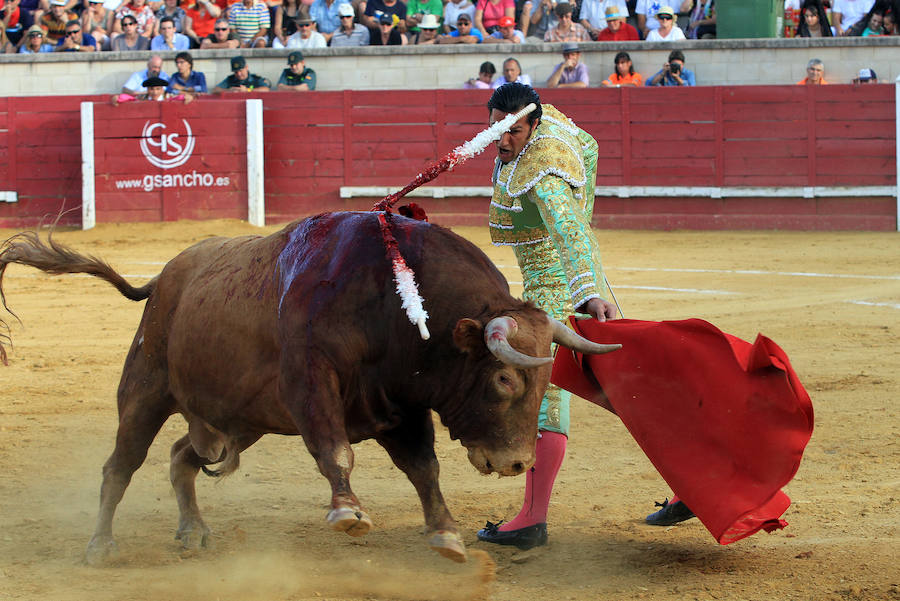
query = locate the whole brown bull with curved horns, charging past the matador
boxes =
[0,213,617,563]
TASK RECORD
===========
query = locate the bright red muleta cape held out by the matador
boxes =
[551,318,813,545]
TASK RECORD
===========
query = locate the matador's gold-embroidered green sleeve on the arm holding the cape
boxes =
[528,172,605,309]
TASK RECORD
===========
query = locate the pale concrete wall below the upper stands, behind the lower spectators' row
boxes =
[0,37,900,96]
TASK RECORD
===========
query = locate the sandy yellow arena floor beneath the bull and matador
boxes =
[0,221,900,601]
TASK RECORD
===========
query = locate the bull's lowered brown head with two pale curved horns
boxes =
[450,308,621,476]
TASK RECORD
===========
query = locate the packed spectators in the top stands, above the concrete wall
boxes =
[0,0,900,53]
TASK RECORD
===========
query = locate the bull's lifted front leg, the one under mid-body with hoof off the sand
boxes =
[286,362,372,536]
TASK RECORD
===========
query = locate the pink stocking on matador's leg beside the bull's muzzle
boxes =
[499,430,568,532]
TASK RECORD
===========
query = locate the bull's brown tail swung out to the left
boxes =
[0,232,157,364]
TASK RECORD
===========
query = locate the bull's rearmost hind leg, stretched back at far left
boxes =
[85,343,174,565]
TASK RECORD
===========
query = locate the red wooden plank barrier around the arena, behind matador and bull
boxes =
[0,85,896,230]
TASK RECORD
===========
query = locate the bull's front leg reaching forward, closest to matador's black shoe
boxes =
[377,411,466,563]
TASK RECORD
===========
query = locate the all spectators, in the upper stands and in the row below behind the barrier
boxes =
[0,0,884,92]
